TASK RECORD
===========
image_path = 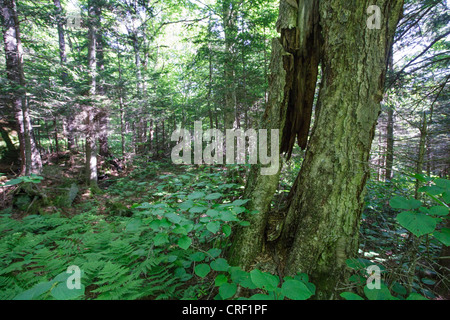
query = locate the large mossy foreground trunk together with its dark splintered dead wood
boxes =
[232,0,403,299]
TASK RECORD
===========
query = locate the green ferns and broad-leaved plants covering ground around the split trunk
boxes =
[0,155,450,300]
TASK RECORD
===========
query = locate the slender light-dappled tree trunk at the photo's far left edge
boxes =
[0,0,42,175]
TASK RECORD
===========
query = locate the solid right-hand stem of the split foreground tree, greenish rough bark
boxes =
[278,0,403,299]
